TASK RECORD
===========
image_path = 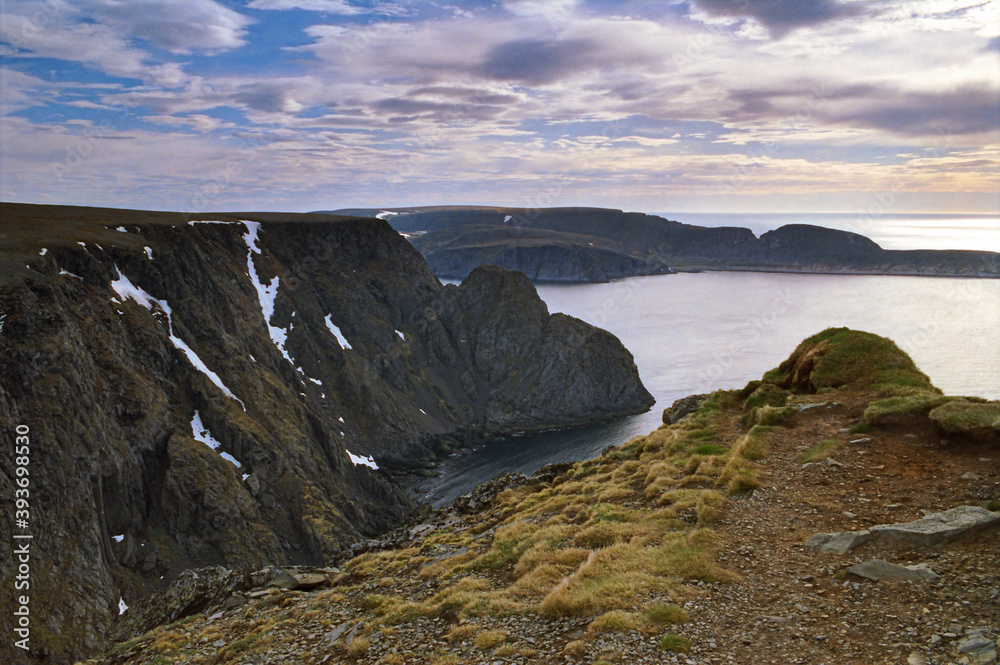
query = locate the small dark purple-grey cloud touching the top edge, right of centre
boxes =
[693,0,862,39]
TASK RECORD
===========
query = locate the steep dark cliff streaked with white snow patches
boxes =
[0,204,652,662]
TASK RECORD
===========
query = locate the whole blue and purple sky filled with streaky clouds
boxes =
[0,0,1000,212]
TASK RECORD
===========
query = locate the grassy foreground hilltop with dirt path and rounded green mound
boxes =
[100,328,1000,665]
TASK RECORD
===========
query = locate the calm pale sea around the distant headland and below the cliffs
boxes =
[410,213,1000,506]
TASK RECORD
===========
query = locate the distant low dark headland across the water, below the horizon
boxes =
[322,206,1000,282]
